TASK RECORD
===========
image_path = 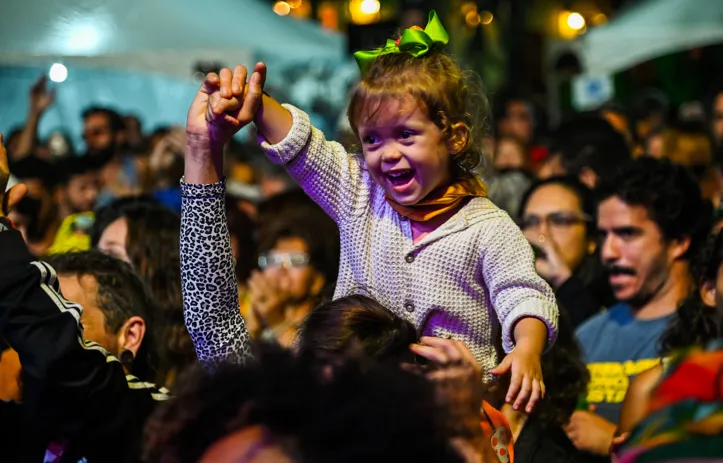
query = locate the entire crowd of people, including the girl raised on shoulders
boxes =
[0,15,723,463]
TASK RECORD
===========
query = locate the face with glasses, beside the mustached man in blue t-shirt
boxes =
[522,183,595,271]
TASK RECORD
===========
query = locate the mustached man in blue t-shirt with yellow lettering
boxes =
[566,158,711,455]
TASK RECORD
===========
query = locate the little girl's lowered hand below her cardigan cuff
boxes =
[492,344,545,413]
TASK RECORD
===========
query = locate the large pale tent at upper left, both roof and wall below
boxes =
[0,0,346,149]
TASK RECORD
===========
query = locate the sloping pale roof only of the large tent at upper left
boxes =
[0,0,345,78]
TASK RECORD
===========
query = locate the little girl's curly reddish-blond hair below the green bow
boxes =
[347,51,490,177]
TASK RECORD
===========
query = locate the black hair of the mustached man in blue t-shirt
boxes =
[597,156,713,258]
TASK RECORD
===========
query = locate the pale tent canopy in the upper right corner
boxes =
[580,0,723,74]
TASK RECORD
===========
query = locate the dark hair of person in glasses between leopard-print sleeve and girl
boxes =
[258,190,339,288]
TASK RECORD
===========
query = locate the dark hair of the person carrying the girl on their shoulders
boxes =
[297,295,418,365]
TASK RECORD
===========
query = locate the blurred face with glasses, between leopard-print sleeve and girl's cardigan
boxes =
[264,237,326,302]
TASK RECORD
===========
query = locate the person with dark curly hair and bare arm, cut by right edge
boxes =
[618,233,723,434]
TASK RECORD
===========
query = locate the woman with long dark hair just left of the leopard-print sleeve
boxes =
[91,198,196,387]
